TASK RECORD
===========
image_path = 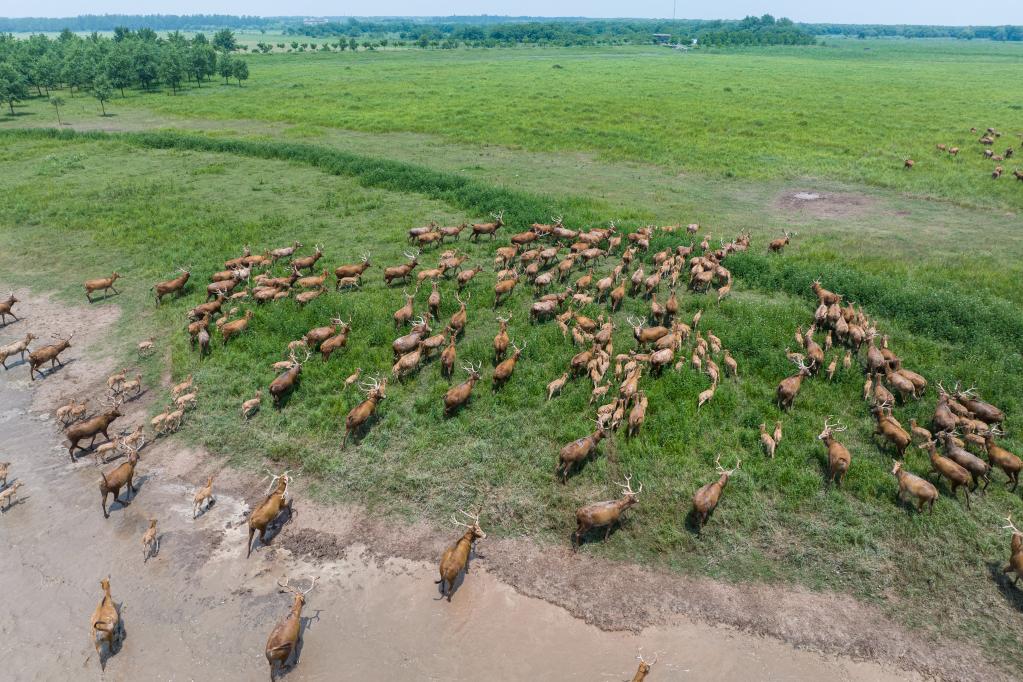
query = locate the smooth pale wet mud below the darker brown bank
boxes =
[0,290,937,681]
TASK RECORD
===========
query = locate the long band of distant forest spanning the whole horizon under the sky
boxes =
[0,14,1023,47]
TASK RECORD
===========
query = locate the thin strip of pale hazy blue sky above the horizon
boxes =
[7,0,1023,26]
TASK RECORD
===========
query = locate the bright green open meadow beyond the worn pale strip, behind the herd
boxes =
[3,40,1023,210]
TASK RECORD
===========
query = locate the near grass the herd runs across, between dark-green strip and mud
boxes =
[0,129,1023,670]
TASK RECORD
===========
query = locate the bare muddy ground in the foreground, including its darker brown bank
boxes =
[0,287,1007,681]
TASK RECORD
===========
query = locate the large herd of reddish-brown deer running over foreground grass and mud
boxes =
[0,206,1023,679]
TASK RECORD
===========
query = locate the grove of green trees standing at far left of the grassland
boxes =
[0,28,249,113]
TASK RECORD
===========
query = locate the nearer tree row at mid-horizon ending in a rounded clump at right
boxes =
[286,14,815,47]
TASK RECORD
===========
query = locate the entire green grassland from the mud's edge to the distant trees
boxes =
[0,41,1023,670]
